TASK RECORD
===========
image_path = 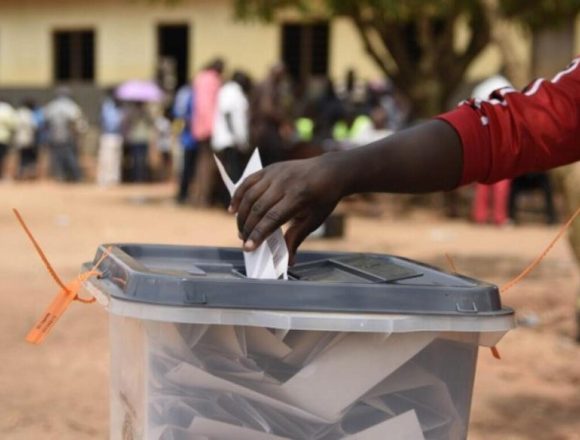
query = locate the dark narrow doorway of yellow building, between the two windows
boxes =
[157,24,189,88]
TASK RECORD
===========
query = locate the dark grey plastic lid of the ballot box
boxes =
[85,244,513,316]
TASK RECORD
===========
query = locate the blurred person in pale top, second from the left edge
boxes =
[14,99,38,180]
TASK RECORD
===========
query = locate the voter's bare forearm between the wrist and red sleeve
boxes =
[336,120,463,195]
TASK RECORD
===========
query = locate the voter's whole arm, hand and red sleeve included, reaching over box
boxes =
[231,59,580,260]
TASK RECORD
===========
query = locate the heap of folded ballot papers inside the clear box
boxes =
[139,321,466,440]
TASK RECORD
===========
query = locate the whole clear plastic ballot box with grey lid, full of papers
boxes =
[88,245,513,440]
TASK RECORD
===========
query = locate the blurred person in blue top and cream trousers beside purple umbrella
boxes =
[97,89,123,186]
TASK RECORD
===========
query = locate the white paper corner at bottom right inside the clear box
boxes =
[346,410,425,440]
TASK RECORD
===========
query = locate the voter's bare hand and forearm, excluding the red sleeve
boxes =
[231,121,462,260]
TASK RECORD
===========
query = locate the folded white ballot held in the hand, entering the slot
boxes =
[214,148,288,279]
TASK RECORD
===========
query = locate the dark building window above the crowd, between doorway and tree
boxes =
[282,22,329,81]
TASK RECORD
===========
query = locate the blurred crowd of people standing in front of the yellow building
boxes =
[0,58,409,207]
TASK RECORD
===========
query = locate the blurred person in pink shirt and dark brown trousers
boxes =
[192,58,224,207]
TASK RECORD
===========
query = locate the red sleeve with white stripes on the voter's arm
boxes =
[437,57,580,184]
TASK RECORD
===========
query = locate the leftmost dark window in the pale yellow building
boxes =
[53,30,95,82]
